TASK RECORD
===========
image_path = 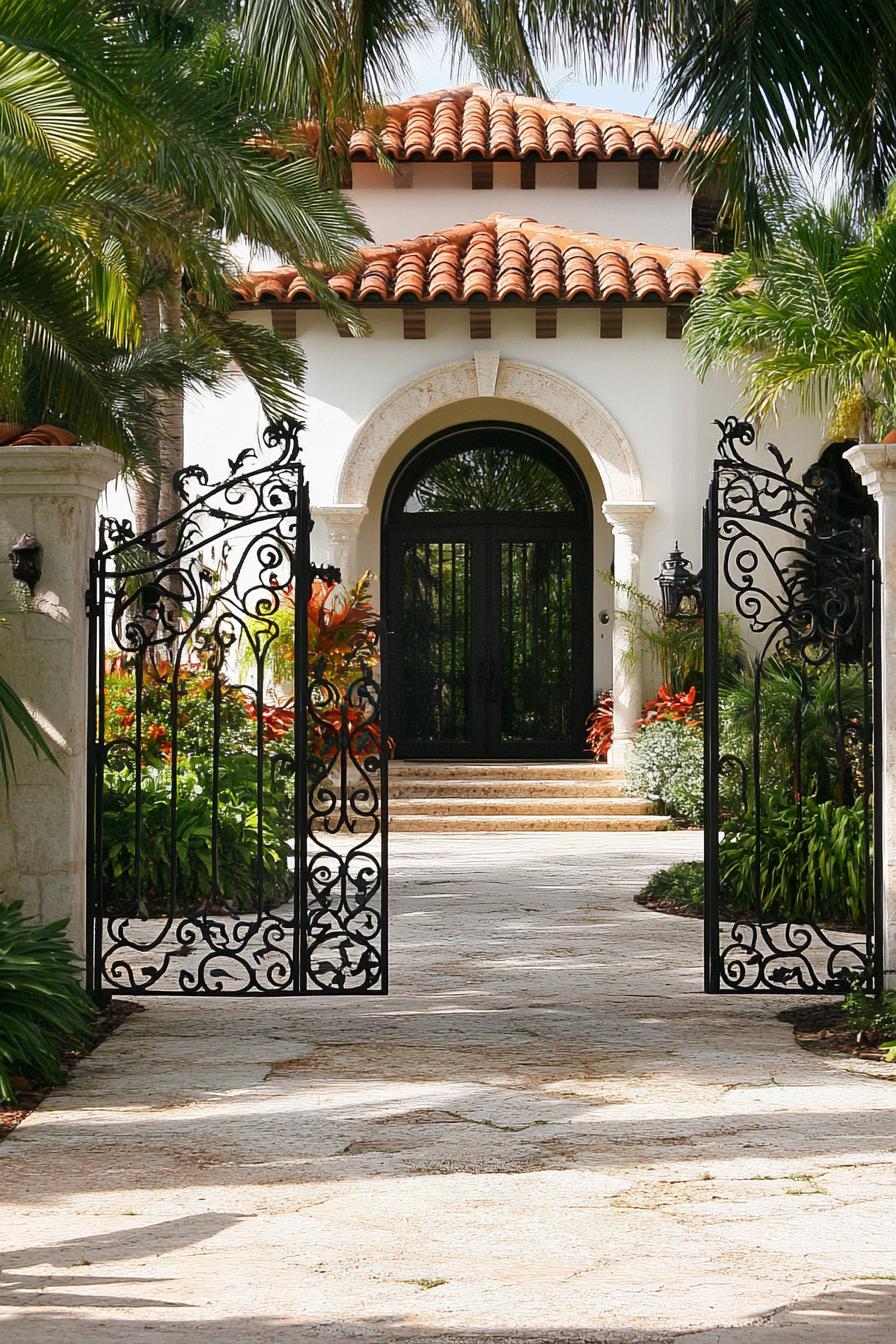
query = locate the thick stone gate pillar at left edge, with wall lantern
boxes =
[0,444,120,954]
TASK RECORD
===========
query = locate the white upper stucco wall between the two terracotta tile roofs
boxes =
[345,163,690,247]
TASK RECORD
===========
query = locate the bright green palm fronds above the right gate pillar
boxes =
[685,190,896,442]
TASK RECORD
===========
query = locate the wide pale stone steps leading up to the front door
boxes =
[388,761,669,832]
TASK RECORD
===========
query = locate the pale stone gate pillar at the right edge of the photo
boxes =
[844,444,896,988]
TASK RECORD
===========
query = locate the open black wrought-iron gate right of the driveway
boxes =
[704,417,883,993]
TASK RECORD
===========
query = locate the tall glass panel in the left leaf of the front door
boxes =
[400,542,472,743]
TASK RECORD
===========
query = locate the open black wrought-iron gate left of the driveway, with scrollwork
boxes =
[87,421,387,995]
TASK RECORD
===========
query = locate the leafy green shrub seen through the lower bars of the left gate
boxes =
[103,755,292,915]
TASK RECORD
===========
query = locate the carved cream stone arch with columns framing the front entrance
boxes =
[314,351,654,762]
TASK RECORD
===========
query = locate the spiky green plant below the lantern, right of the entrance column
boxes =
[602,573,746,699]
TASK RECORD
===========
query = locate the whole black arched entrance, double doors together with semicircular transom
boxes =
[382,421,592,759]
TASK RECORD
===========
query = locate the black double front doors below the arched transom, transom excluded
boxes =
[384,515,591,758]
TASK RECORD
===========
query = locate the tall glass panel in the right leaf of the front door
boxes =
[500,540,578,742]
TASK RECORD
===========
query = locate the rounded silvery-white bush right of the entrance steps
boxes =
[626,719,703,825]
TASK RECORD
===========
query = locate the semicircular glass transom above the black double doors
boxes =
[403,441,575,513]
